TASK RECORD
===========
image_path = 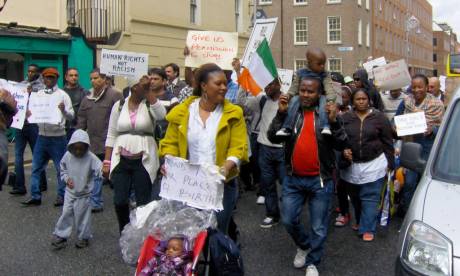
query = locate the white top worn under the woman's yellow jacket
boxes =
[187,99,239,165]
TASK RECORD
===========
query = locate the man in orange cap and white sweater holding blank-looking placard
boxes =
[22,68,74,206]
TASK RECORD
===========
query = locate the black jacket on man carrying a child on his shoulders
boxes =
[267,107,348,180]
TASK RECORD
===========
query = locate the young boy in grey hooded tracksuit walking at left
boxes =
[51,129,102,249]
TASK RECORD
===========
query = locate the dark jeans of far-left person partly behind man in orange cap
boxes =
[13,124,46,192]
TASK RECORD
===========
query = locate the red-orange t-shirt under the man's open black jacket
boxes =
[292,111,319,176]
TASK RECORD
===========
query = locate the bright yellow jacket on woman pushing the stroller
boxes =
[160,96,248,179]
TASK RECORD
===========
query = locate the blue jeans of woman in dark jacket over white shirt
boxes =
[348,178,385,235]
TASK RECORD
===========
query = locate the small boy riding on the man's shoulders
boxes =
[276,48,337,136]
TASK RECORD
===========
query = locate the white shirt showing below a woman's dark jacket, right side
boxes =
[340,153,388,185]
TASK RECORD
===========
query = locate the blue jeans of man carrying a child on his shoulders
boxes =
[281,176,334,266]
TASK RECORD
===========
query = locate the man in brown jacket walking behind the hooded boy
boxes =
[77,68,123,213]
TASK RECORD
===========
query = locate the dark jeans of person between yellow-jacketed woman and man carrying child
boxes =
[259,144,286,219]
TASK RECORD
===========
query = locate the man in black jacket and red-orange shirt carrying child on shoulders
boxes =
[268,77,347,276]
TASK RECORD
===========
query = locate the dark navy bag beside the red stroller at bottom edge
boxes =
[208,229,244,276]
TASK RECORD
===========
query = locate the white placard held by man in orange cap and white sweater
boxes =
[28,93,62,125]
